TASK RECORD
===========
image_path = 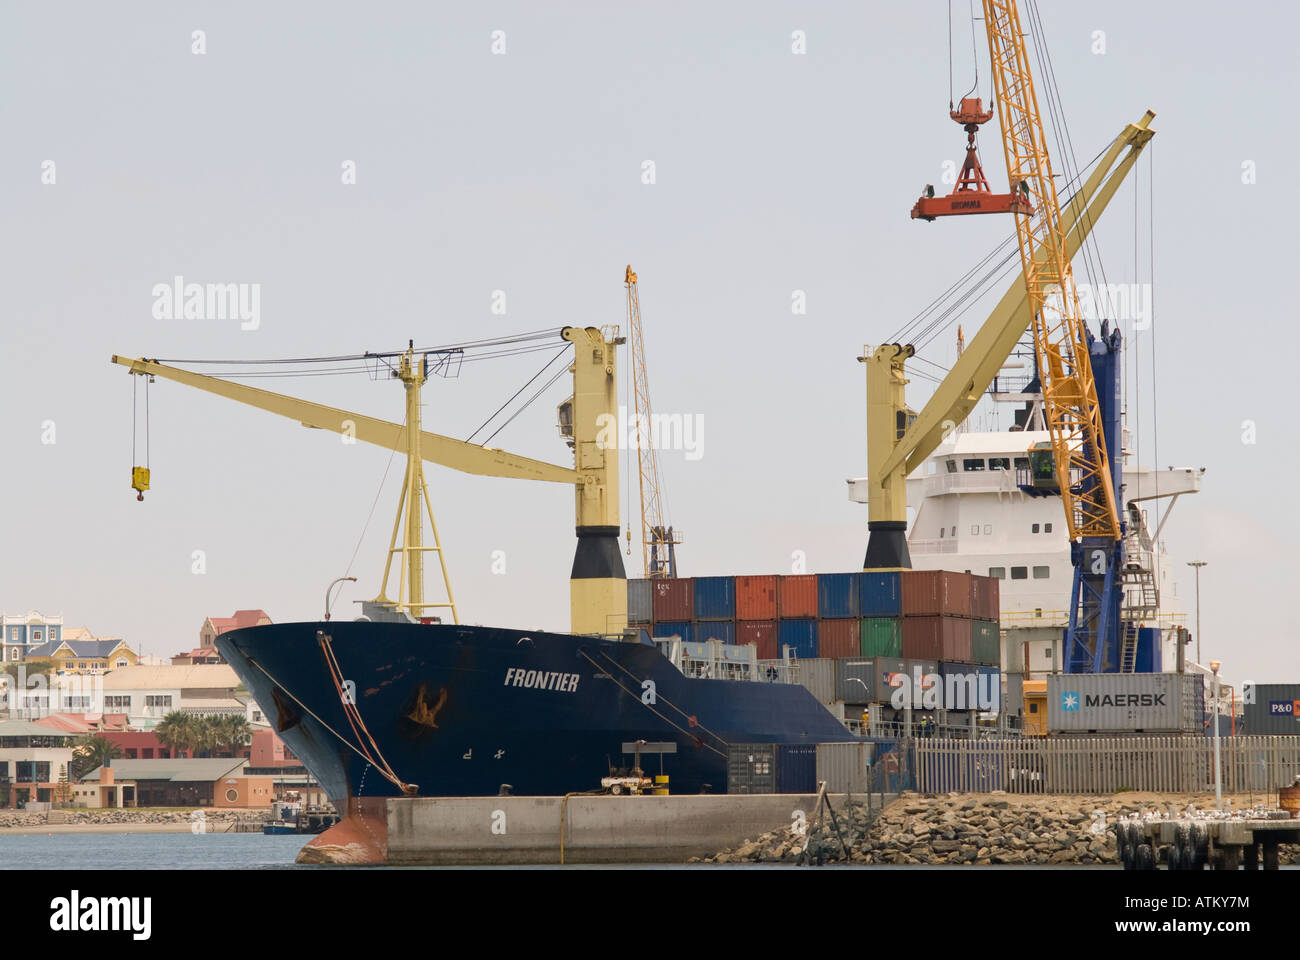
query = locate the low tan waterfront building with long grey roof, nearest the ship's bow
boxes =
[74,757,276,808]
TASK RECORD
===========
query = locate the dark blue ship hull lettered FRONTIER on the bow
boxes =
[216,620,855,813]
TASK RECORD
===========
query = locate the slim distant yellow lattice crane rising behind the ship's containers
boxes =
[623,264,681,580]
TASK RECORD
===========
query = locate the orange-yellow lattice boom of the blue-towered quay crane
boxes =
[983,0,1123,541]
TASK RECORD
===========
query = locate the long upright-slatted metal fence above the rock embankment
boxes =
[913,736,1300,795]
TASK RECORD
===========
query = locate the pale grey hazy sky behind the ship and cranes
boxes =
[0,0,1300,682]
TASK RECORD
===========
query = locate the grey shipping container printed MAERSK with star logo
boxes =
[1048,674,1205,734]
